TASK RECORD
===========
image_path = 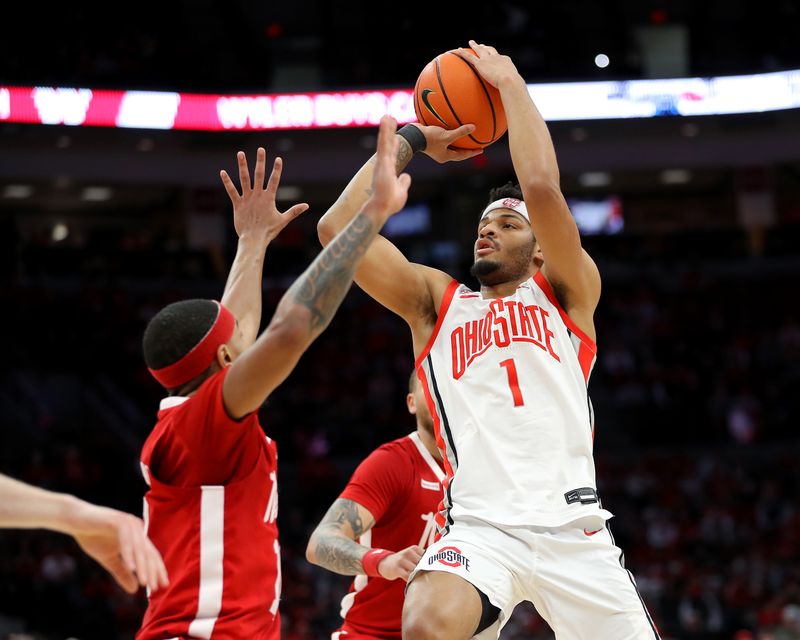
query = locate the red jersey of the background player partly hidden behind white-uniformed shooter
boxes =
[333,432,445,640]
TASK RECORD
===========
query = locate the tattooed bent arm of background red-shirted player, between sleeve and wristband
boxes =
[315,498,373,576]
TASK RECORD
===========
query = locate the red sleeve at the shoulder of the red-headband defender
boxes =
[152,368,263,486]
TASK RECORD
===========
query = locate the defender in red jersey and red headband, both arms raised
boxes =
[136,118,410,640]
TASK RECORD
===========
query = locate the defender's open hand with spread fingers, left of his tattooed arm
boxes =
[219,147,308,242]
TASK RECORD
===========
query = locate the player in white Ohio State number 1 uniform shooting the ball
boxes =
[318,41,659,640]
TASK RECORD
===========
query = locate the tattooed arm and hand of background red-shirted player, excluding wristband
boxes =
[306,498,423,580]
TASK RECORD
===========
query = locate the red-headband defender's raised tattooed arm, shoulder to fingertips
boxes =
[222,117,411,418]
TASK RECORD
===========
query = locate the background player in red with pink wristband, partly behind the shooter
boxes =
[306,372,445,640]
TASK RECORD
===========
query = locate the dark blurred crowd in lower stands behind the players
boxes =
[0,214,800,640]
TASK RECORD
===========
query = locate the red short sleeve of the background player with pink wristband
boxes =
[339,443,414,522]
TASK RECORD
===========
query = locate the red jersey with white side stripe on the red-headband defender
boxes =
[136,369,281,640]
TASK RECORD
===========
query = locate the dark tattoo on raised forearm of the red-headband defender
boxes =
[289,214,377,332]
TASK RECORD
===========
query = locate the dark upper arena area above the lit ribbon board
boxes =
[0,0,800,92]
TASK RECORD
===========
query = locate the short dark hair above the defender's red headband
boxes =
[142,300,218,369]
